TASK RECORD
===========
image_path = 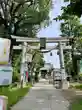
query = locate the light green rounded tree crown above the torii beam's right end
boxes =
[60,15,80,37]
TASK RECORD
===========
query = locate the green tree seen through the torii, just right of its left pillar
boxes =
[26,50,44,82]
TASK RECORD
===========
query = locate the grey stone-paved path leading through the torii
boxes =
[11,79,69,110]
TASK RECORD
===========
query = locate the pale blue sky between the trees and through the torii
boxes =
[37,0,66,68]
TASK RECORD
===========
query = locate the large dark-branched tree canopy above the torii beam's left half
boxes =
[0,0,52,37]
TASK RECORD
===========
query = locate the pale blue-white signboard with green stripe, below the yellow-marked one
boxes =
[0,65,13,85]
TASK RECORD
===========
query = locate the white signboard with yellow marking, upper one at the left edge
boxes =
[0,38,11,65]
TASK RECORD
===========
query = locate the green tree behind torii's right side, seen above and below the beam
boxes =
[54,3,82,76]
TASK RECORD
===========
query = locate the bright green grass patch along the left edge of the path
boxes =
[0,86,30,110]
